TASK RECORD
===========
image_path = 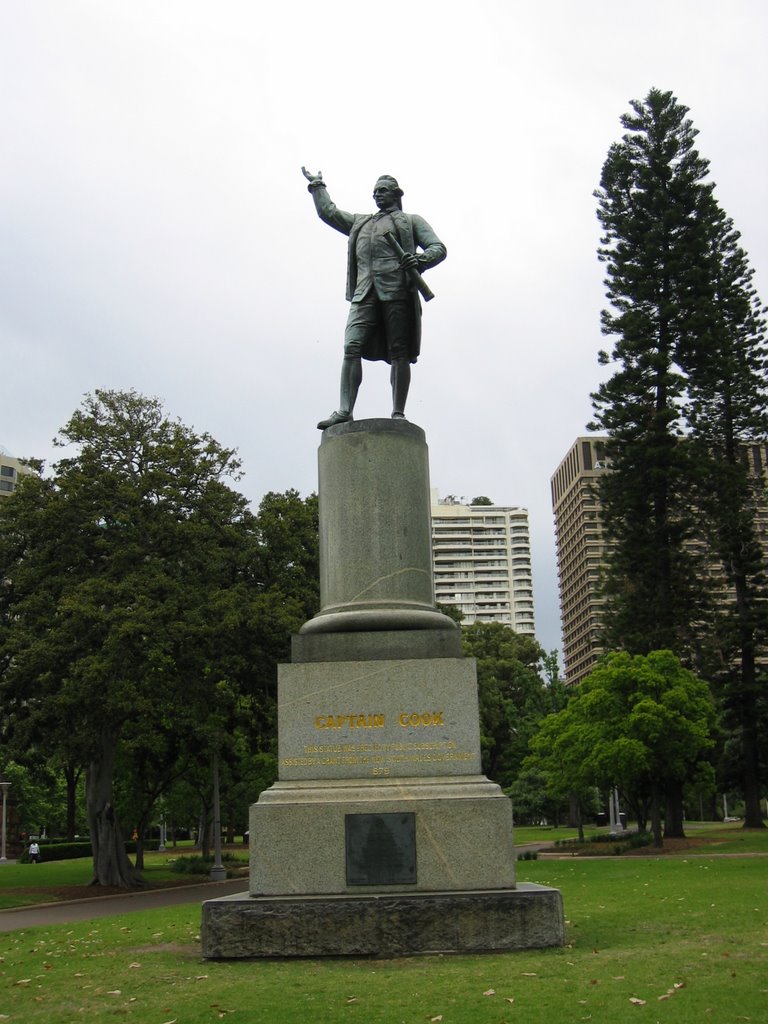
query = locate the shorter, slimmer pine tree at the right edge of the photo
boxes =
[681,203,768,828]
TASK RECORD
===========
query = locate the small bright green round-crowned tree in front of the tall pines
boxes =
[525,650,715,846]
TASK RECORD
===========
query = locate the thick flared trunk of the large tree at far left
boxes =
[85,737,144,889]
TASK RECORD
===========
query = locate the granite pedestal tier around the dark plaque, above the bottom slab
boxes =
[250,775,515,898]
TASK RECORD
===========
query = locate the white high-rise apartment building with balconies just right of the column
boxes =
[432,492,535,636]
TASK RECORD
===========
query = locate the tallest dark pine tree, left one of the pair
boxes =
[593,89,712,654]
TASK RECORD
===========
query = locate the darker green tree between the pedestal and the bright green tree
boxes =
[462,623,549,786]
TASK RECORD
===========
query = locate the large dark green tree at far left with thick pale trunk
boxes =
[0,391,249,886]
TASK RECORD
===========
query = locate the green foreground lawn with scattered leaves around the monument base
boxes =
[0,856,768,1024]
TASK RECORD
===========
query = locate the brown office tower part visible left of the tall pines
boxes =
[551,437,607,684]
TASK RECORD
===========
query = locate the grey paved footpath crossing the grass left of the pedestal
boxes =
[0,879,248,932]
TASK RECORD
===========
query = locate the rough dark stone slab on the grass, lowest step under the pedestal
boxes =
[202,884,565,959]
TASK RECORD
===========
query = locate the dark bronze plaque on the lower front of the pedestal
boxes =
[344,811,416,886]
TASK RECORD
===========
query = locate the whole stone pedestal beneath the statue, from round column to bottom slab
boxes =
[203,420,564,957]
